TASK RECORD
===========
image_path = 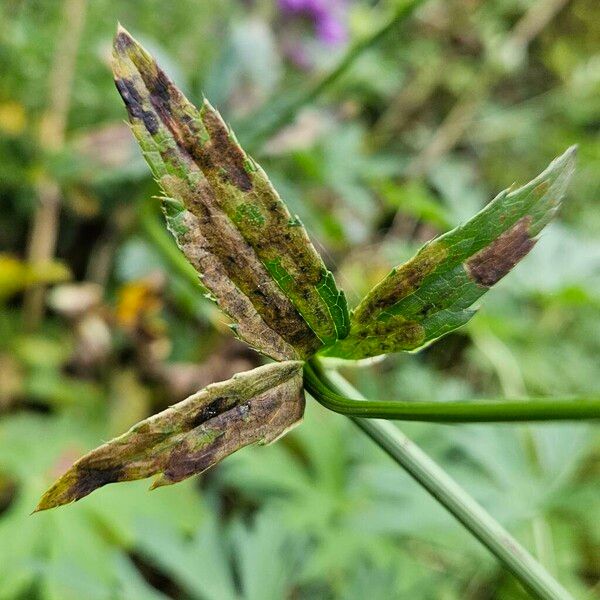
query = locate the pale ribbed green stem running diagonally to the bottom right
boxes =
[312,360,572,600]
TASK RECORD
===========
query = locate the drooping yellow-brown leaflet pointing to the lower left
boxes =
[36,361,304,510]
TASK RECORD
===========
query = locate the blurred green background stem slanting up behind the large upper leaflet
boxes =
[237,0,423,149]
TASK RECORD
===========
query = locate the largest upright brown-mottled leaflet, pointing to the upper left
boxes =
[113,28,349,360]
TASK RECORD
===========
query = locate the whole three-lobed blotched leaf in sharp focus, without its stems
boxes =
[37,24,574,510]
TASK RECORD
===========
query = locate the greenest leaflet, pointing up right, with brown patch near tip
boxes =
[323,147,575,359]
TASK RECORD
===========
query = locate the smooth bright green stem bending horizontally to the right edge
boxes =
[304,361,600,423]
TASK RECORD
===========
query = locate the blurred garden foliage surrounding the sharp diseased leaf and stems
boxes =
[0,0,600,600]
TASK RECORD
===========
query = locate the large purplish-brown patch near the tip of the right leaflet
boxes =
[465,215,536,287]
